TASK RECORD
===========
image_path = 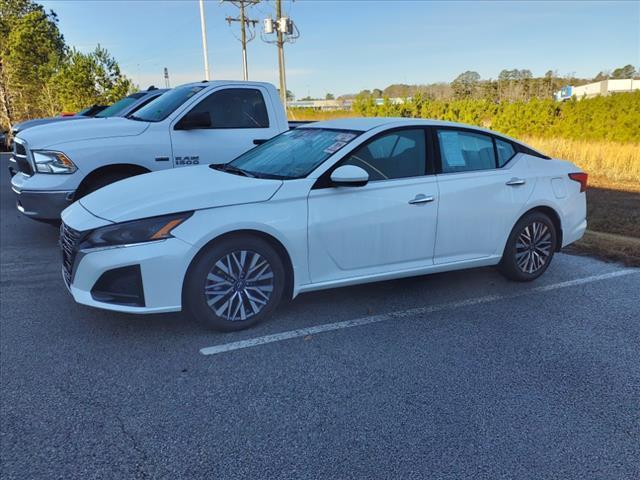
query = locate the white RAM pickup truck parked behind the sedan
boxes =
[11,81,289,222]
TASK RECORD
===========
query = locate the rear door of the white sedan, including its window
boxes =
[433,127,535,264]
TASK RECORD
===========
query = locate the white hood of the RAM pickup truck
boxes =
[18,117,149,149]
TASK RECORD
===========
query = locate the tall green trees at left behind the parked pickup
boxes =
[0,0,135,130]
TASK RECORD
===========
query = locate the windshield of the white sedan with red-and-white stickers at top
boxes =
[228,128,361,178]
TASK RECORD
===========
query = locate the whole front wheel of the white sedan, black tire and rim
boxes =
[182,236,286,332]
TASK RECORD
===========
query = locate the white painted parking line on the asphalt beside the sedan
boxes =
[200,268,640,355]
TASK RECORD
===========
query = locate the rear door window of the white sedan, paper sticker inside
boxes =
[438,129,496,173]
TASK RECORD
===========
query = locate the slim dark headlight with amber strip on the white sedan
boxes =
[80,212,193,249]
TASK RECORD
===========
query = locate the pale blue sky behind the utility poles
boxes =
[39,0,640,98]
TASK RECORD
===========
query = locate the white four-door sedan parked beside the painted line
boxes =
[61,118,587,330]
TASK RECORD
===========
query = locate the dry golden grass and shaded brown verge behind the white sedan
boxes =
[289,109,640,266]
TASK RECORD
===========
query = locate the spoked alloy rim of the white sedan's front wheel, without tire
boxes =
[204,250,274,322]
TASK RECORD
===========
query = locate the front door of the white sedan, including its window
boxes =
[308,128,438,283]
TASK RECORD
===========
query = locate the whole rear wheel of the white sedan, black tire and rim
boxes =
[499,212,558,282]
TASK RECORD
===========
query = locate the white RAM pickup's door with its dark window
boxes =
[171,85,279,167]
